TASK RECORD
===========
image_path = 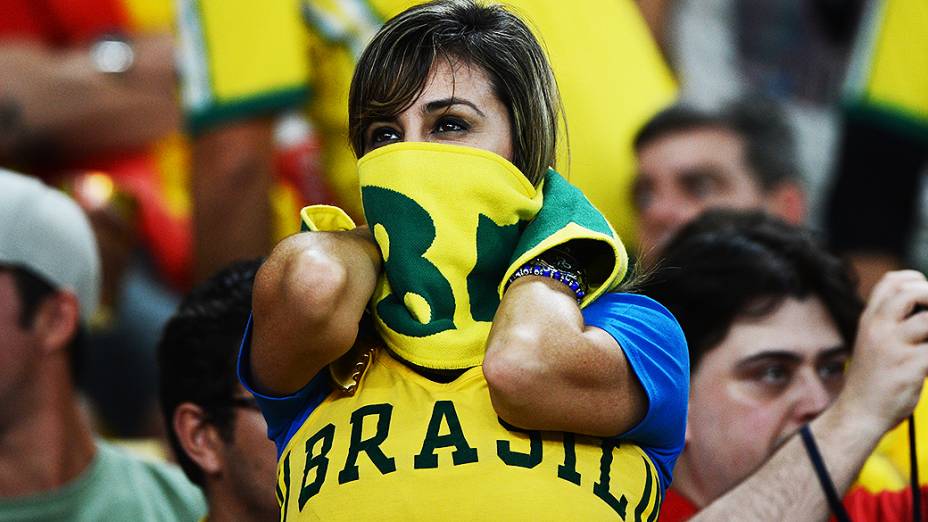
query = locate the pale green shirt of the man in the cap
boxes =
[0,441,206,522]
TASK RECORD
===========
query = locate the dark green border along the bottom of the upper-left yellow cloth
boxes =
[185,86,312,136]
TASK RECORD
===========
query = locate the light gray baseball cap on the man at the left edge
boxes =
[0,169,101,322]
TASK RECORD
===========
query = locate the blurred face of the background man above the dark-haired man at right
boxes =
[633,127,765,255]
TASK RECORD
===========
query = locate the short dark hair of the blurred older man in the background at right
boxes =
[634,97,799,191]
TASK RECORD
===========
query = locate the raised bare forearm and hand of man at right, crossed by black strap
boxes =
[691,271,928,521]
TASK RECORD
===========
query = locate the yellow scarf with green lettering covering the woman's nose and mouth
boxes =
[358,143,542,369]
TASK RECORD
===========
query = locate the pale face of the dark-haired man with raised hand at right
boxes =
[674,297,849,505]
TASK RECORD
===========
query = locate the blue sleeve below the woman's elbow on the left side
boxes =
[236,317,332,459]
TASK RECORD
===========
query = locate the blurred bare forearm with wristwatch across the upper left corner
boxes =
[0,34,180,160]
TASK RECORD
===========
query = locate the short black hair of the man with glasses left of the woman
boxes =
[158,259,263,486]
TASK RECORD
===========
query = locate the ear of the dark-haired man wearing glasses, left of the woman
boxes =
[171,402,224,476]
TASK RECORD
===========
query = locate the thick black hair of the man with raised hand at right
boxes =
[640,209,863,371]
